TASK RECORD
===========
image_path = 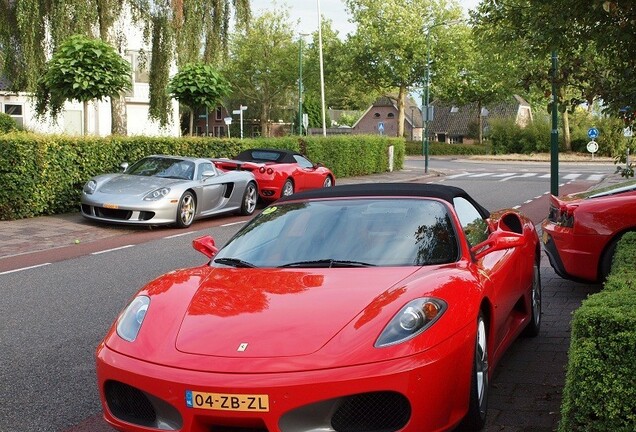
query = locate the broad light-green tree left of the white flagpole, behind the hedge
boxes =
[225,11,298,137]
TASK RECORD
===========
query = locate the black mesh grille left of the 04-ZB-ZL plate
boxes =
[104,381,157,427]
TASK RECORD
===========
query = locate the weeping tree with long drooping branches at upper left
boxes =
[0,0,251,134]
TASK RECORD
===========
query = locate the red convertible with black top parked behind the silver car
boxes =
[214,149,336,201]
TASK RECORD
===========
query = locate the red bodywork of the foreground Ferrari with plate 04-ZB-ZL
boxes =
[97,186,539,432]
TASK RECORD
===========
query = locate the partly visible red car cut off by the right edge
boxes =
[542,181,636,282]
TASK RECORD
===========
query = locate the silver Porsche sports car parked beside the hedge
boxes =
[81,155,258,228]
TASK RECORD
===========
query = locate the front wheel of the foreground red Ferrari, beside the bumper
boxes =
[461,312,489,431]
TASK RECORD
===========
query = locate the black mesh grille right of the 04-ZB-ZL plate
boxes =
[331,392,411,432]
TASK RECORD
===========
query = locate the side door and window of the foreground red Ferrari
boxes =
[454,197,523,353]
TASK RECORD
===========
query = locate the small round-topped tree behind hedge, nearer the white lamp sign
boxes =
[168,63,230,135]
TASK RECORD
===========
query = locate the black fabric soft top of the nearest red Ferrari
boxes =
[277,183,490,218]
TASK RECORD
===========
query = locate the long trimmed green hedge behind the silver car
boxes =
[0,132,404,220]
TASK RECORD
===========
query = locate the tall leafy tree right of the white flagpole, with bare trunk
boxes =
[346,0,462,136]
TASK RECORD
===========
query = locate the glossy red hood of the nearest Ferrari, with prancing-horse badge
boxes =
[176,267,414,358]
